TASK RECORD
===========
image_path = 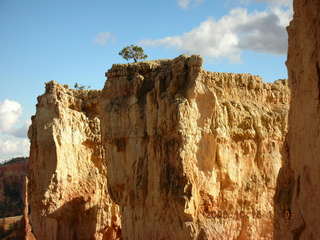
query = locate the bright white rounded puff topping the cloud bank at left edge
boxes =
[0,99,22,133]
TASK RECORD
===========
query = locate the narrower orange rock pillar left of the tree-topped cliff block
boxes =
[28,82,120,240]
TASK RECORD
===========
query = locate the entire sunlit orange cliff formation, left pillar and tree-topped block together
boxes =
[26,56,290,240]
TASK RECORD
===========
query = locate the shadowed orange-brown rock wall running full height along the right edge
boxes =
[275,0,320,240]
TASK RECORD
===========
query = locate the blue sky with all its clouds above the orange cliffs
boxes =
[0,0,292,160]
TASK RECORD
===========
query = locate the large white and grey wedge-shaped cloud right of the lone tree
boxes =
[140,7,291,61]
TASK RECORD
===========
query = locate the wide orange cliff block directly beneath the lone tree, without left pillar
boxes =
[100,56,289,240]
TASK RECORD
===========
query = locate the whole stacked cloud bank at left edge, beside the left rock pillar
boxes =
[0,99,30,162]
